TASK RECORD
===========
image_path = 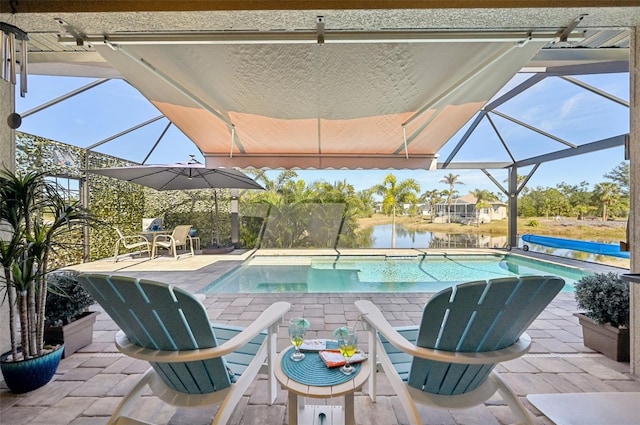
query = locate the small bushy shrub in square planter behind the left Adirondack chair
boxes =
[44,271,98,358]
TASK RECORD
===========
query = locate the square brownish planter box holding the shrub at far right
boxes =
[574,313,629,362]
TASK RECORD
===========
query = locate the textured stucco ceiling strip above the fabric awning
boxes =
[0,6,640,34]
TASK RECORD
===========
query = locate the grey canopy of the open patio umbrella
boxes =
[89,162,264,190]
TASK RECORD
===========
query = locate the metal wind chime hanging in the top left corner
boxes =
[0,22,29,97]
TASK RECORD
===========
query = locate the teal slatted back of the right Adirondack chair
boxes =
[407,276,564,395]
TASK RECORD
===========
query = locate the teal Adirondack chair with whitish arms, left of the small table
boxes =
[78,274,291,425]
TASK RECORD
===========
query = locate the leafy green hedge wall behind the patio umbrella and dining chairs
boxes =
[16,132,242,265]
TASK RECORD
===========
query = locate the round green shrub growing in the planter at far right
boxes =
[575,272,629,328]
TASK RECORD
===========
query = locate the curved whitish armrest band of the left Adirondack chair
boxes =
[115,301,291,363]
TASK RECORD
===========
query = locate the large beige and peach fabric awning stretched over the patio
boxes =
[95,36,545,169]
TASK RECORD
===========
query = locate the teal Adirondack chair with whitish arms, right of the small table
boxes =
[355,276,564,425]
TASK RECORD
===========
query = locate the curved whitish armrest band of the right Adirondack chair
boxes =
[355,300,531,364]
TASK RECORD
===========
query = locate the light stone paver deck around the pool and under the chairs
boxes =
[0,248,640,425]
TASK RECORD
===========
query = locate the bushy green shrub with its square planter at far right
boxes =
[575,272,629,361]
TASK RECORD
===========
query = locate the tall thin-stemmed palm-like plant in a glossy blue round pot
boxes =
[0,169,89,393]
